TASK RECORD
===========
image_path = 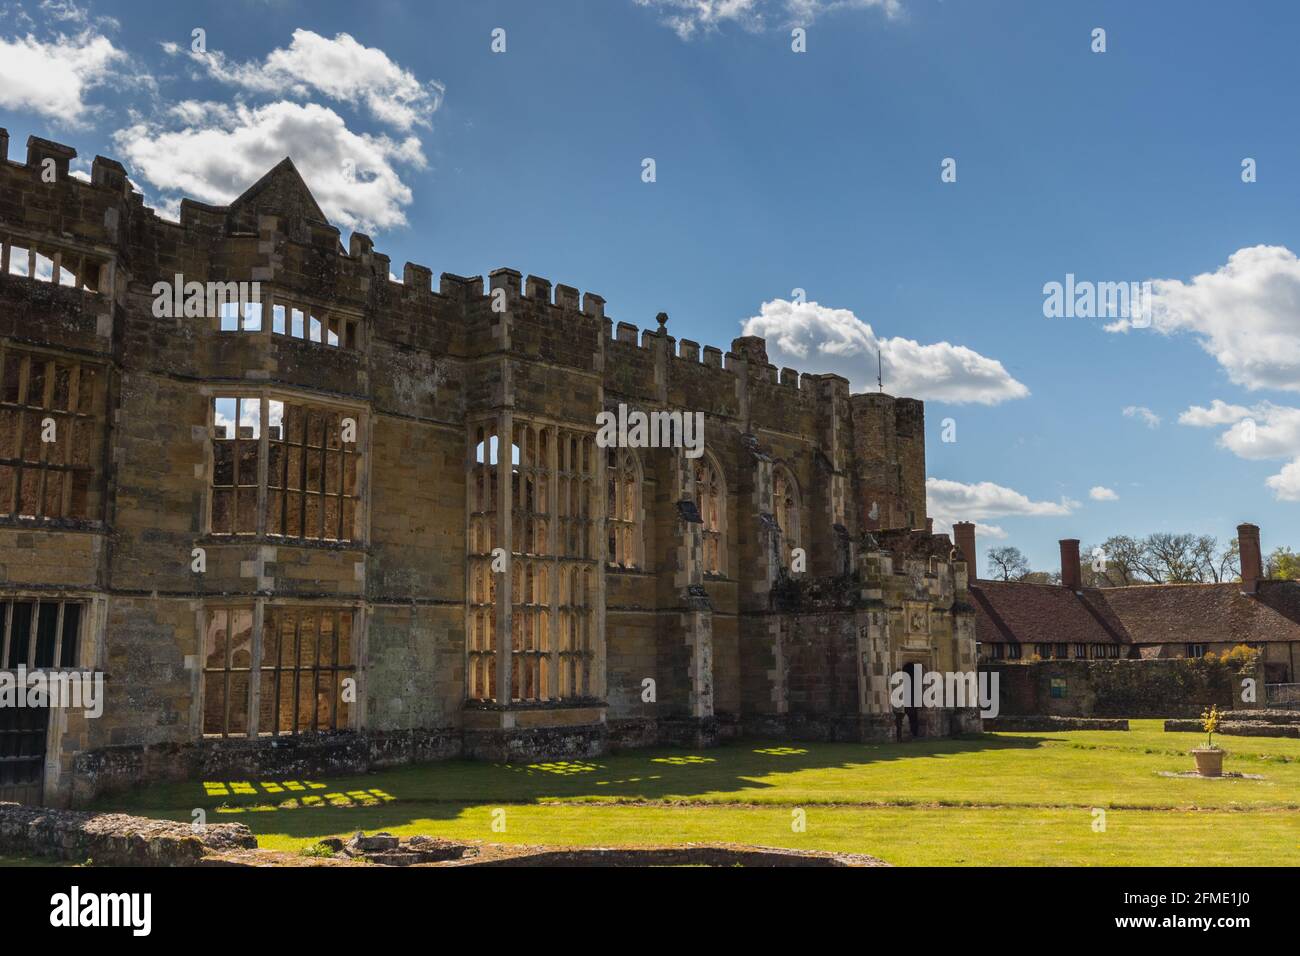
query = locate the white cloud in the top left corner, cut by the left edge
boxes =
[0,30,126,126]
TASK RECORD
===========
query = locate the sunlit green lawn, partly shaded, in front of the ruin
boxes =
[86,721,1300,865]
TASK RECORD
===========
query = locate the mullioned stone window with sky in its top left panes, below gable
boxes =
[203,385,371,548]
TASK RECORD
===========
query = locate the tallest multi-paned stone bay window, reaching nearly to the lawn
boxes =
[465,411,606,706]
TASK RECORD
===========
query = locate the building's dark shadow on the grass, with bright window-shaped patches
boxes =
[96,734,1047,836]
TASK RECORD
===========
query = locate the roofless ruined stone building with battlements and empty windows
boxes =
[0,131,975,803]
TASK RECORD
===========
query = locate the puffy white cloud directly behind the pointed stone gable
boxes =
[113,100,425,230]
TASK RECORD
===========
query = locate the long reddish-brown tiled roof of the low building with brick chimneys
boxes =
[971,581,1300,644]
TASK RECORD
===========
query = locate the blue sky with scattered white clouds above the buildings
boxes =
[0,0,1300,568]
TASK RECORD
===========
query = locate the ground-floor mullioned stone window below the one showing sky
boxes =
[191,598,367,740]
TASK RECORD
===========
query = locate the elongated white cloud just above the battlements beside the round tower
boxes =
[742,299,1030,405]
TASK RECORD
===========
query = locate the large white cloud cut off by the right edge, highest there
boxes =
[1106,246,1300,392]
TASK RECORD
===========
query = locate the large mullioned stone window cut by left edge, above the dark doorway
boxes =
[0,339,108,525]
